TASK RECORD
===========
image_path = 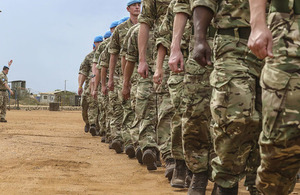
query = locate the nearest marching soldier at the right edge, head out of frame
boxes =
[248,0,300,195]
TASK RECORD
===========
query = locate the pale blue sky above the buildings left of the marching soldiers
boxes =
[0,0,129,94]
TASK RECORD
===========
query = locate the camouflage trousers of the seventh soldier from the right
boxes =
[108,82,123,143]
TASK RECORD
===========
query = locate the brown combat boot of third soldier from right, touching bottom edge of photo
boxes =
[188,171,208,195]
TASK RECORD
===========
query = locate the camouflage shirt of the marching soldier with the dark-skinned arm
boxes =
[189,0,250,28]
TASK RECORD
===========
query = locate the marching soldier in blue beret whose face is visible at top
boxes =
[108,0,141,156]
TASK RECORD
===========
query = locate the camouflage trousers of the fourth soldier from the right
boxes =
[154,59,175,161]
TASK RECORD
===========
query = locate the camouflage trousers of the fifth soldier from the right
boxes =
[137,72,158,151]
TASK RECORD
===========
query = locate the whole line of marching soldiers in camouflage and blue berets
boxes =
[78,0,300,195]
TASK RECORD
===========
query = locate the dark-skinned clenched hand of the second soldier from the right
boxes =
[193,39,212,66]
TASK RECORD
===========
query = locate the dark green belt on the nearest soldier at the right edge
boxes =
[270,0,300,15]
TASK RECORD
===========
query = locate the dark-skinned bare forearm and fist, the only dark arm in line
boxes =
[193,6,214,66]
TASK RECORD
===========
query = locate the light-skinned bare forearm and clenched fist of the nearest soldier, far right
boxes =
[248,0,273,59]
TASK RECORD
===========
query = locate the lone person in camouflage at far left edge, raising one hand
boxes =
[0,60,14,123]
